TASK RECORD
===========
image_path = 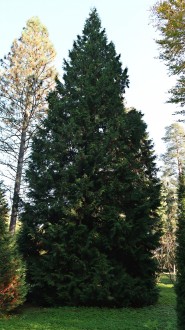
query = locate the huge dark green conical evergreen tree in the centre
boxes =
[19,9,160,307]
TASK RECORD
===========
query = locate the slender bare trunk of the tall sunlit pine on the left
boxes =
[9,125,27,234]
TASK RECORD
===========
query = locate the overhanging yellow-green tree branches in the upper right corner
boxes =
[152,0,185,114]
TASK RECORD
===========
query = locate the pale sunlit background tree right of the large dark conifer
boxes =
[156,123,185,279]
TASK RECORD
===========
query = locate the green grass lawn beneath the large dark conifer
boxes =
[0,277,176,330]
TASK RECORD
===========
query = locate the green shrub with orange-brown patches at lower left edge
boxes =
[0,182,27,313]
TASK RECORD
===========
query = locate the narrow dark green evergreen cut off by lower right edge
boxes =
[176,173,185,330]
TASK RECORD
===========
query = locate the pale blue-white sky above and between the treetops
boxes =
[0,0,182,159]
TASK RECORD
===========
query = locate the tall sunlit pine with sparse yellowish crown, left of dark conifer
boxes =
[0,17,56,233]
